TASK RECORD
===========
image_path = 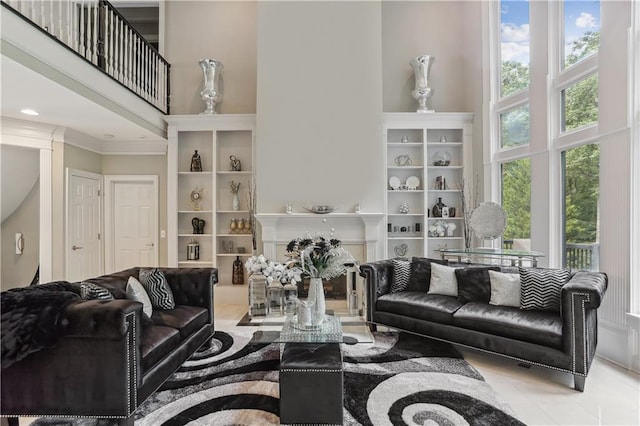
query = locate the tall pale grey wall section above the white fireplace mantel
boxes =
[256,2,384,212]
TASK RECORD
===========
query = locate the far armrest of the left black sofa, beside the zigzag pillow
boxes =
[158,268,218,324]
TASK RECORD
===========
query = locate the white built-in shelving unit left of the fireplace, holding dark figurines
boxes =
[166,114,256,286]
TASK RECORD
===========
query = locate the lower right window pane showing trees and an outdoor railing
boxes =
[562,144,600,270]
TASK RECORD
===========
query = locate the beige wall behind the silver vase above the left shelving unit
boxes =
[165,0,257,114]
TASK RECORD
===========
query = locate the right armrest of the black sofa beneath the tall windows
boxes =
[561,272,607,376]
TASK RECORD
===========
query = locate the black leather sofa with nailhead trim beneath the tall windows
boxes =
[360,258,607,391]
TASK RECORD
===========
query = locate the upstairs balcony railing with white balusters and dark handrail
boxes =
[1,0,171,114]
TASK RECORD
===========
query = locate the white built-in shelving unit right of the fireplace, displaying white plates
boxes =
[384,113,473,258]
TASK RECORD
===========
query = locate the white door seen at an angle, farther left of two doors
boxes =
[66,169,102,282]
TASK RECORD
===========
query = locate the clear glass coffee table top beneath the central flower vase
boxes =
[246,310,374,344]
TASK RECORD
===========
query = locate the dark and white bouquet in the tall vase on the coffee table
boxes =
[286,234,356,279]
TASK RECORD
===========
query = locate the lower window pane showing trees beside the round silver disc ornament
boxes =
[501,158,531,250]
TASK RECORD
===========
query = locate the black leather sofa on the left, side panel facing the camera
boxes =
[0,268,218,424]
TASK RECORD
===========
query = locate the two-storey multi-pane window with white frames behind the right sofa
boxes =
[489,0,600,268]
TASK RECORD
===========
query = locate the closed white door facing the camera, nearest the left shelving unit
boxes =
[107,176,158,271]
